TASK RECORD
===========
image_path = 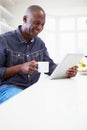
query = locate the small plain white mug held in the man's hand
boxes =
[38,61,49,73]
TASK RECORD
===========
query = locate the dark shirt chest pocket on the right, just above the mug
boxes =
[28,49,44,61]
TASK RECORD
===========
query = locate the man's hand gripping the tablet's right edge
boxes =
[66,66,78,78]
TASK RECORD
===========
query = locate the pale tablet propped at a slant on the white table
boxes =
[50,53,84,79]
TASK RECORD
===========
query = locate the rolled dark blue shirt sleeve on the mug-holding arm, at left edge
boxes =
[0,36,6,82]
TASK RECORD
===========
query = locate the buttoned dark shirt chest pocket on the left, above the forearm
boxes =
[6,49,25,66]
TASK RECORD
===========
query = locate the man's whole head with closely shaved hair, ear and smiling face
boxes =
[22,5,45,38]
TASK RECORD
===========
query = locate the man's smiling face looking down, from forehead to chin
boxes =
[25,12,45,37]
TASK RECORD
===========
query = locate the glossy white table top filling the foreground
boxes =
[0,75,87,130]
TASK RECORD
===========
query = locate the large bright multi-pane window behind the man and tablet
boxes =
[40,15,87,62]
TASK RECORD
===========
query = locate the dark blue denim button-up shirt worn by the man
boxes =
[0,26,56,89]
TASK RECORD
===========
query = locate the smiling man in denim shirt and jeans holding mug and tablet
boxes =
[0,5,77,103]
